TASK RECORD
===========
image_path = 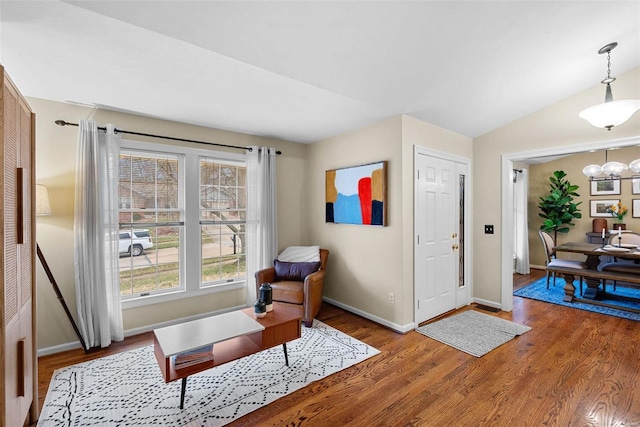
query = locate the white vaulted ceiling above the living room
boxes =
[0,0,640,143]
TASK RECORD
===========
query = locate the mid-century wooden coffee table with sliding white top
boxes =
[153,302,302,409]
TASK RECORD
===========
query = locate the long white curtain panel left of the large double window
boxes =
[74,120,124,348]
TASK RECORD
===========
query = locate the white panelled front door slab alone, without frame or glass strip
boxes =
[414,153,464,324]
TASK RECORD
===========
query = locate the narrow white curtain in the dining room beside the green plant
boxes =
[513,169,530,274]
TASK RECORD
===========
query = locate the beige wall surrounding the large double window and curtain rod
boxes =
[32,98,308,349]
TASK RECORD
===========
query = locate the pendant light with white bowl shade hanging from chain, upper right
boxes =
[578,42,640,130]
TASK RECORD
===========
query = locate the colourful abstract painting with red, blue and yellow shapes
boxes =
[325,161,387,226]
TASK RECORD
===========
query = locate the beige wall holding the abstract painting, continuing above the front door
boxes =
[307,116,472,330]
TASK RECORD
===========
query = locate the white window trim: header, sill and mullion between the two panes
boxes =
[120,139,247,310]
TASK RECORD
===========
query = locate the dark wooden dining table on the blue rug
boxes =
[554,242,640,300]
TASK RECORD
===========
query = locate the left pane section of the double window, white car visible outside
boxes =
[118,150,184,296]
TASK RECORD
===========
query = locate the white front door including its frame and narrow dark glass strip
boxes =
[414,146,472,324]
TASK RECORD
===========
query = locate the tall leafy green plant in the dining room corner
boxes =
[538,171,582,242]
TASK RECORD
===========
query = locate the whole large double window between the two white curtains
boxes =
[118,141,247,307]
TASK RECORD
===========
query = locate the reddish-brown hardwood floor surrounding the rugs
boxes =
[39,271,640,426]
